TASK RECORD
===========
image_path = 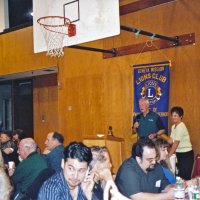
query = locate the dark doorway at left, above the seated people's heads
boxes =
[0,79,33,137]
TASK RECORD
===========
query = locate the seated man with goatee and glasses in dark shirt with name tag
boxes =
[116,138,173,200]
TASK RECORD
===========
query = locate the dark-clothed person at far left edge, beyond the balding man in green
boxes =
[0,131,19,165]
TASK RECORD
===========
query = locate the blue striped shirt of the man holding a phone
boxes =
[38,172,87,200]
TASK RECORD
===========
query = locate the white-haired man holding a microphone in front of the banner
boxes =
[133,98,165,139]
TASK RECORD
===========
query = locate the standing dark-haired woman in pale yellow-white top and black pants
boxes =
[169,106,194,180]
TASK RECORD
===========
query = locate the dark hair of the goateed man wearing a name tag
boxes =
[132,138,156,158]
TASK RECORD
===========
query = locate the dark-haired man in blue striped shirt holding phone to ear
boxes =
[38,142,100,200]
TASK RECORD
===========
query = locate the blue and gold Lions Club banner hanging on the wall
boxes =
[133,61,170,133]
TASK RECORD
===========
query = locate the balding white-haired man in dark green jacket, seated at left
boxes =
[8,138,47,199]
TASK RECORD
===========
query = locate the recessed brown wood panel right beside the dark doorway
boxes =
[33,74,58,150]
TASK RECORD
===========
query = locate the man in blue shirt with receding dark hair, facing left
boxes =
[43,132,64,172]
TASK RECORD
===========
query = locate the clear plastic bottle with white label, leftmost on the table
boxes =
[174,176,185,200]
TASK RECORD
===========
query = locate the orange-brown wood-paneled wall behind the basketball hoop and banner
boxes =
[0,0,200,157]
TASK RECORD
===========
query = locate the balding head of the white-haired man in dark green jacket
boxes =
[18,138,37,159]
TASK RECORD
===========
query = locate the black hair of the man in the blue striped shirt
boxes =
[64,142,92,165]
